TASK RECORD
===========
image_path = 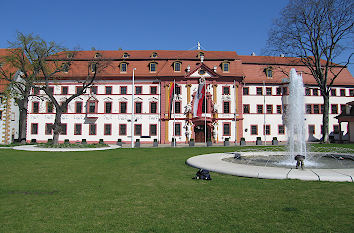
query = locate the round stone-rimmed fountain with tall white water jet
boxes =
[187,68,354,182]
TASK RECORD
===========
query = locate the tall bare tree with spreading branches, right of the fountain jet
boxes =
[267,0,354,143]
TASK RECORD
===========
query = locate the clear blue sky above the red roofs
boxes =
[0,0,354,73]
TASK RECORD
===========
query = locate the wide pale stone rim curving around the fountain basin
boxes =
[186,153,354,182]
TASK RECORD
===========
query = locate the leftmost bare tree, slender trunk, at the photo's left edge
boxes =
[0,32,49,142]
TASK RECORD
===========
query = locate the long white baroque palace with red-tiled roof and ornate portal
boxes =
[27,50,354,144]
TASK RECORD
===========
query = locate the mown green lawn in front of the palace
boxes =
[0,145,354,233]
